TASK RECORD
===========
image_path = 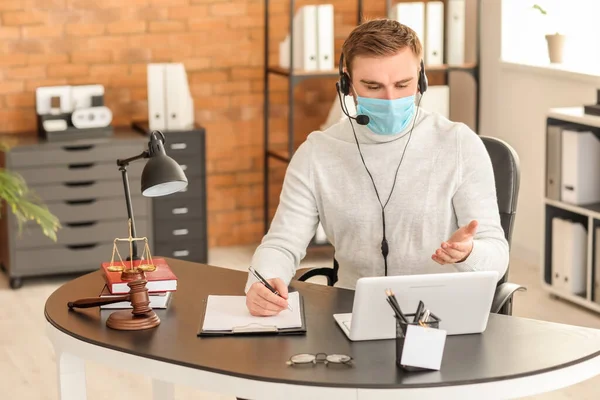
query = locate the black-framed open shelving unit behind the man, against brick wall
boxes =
[263,0,481,238]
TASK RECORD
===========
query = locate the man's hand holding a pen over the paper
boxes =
[246,278,288,317]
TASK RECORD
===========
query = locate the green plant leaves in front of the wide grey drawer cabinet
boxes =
[0,142,61,247]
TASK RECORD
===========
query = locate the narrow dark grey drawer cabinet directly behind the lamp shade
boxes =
[134,123,208,263]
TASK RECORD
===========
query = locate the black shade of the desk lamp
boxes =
[142,153,188,197]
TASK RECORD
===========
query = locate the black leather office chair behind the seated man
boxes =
[295,135,526,315]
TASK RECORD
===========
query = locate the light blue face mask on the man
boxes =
[356,95,415,135]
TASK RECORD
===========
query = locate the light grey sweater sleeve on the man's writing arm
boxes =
[245,140,319,292]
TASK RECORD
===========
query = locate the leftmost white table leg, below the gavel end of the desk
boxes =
[56,353,86,400]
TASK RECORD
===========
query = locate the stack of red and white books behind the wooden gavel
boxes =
[100,257,177,309]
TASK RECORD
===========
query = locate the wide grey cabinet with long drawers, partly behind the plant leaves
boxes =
[0,129,156,288]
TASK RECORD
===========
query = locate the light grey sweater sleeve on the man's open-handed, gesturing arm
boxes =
[453,125,509,279]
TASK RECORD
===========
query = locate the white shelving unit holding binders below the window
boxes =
[541,107,600,312]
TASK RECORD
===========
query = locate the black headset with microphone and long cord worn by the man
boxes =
[335,52,428,276]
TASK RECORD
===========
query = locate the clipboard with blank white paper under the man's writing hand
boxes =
[198,292,306,336]
